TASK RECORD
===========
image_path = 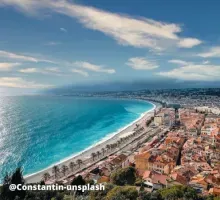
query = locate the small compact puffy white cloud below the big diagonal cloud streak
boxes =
[126,57,159,70]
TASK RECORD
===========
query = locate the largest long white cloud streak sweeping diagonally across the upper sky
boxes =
[0,0,201,50]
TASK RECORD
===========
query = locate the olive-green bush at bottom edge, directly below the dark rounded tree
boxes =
[106,186,138,200]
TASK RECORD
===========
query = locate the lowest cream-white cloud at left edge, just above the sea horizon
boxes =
[0,77,52,88]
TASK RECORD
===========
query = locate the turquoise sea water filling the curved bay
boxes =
[0,96,153,179]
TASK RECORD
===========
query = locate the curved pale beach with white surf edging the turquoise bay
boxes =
[24,99,159,183]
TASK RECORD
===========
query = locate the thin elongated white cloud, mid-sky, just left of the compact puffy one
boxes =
[73,61,115,74]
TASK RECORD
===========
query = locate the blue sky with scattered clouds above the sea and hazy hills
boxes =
[0,0,220,95]
